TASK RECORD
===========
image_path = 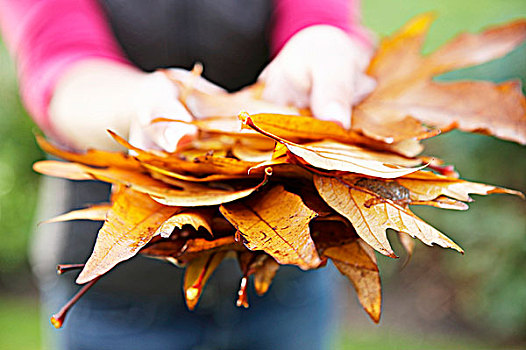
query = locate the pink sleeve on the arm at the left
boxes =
[0,0,129,135]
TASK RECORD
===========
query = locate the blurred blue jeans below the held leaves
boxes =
[42,258,333,350]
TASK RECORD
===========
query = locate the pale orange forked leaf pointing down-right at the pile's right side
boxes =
[314,175,463,257]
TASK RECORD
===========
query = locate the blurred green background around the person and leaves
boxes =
[0,0,526,350]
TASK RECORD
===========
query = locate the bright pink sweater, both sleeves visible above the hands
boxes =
[0,0,368,134]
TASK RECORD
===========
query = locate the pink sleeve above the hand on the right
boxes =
[271,0,371,56]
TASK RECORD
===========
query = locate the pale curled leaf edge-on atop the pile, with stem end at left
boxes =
[239,113,424,178]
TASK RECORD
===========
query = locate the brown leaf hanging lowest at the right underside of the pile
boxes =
[323,239,382,323]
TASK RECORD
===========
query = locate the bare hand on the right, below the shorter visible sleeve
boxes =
[259,25,376,128]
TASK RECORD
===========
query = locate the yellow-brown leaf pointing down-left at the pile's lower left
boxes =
[77,187,180,284]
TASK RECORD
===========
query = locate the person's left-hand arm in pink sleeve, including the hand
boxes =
[0,0,200,150]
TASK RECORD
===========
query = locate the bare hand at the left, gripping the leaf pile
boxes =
[49,60,222,152]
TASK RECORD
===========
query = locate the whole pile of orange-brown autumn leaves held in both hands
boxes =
[34,15,526,326]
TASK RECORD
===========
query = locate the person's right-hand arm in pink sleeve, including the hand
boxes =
[259,0,375,127]
